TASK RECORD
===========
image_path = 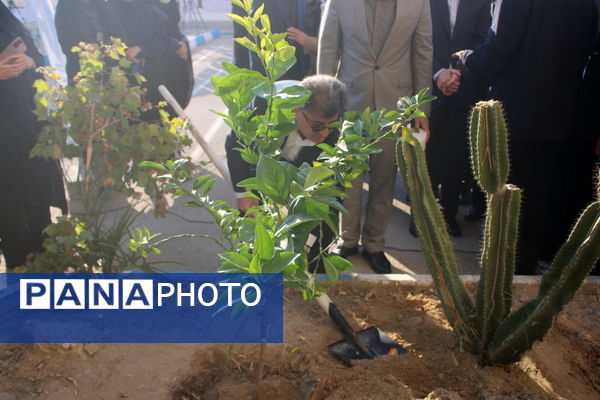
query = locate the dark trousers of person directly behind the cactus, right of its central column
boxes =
[509,140,568,275]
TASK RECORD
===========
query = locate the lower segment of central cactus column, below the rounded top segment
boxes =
[476,185,521,347]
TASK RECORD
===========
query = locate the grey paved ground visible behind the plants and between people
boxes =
[0,4,480,274]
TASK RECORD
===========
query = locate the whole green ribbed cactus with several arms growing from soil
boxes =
[396,101,600,364]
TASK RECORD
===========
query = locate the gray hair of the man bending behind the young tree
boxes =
[301,75,346,118]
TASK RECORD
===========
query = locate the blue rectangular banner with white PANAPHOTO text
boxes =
[0,273,283,343]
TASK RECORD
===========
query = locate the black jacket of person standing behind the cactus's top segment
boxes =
[466,0,598,141]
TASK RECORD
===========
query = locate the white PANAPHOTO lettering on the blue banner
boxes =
[19,279,262,310]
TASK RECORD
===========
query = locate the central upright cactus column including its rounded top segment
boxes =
[469,101,521,347]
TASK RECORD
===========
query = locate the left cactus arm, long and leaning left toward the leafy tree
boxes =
[396,133,478,345]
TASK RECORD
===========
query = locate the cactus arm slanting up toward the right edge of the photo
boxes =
[482,202,600,364]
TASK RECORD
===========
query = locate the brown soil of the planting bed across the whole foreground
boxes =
[0,282,600,400]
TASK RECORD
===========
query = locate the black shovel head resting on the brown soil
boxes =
[328,326,406,367]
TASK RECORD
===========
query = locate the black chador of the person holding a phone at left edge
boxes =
[0,2,67,270]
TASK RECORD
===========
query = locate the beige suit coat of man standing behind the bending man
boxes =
[317,0,433,112]
